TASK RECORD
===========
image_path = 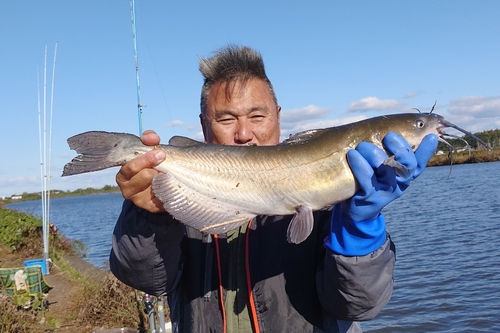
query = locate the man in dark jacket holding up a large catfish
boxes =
[110,46,437,332]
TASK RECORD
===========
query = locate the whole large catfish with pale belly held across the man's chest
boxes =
[63,113,484,243]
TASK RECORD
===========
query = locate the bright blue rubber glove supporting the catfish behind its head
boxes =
[325,132,438,256]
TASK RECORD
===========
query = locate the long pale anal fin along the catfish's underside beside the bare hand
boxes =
[153,173,255,234]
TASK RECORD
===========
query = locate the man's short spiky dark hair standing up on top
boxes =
[199,45,278,115]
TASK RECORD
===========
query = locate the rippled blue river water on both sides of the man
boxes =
[6,162,500,333]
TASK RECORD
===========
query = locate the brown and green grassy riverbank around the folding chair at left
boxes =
[0,208,161,333]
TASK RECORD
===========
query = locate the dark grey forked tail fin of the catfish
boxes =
[62,131,145,177]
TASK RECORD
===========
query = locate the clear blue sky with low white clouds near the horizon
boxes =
[0,0,500,198]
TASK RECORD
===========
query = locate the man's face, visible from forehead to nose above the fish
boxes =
[201,79,281,146]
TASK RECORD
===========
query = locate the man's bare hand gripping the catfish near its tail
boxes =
[116,130,166,213]
